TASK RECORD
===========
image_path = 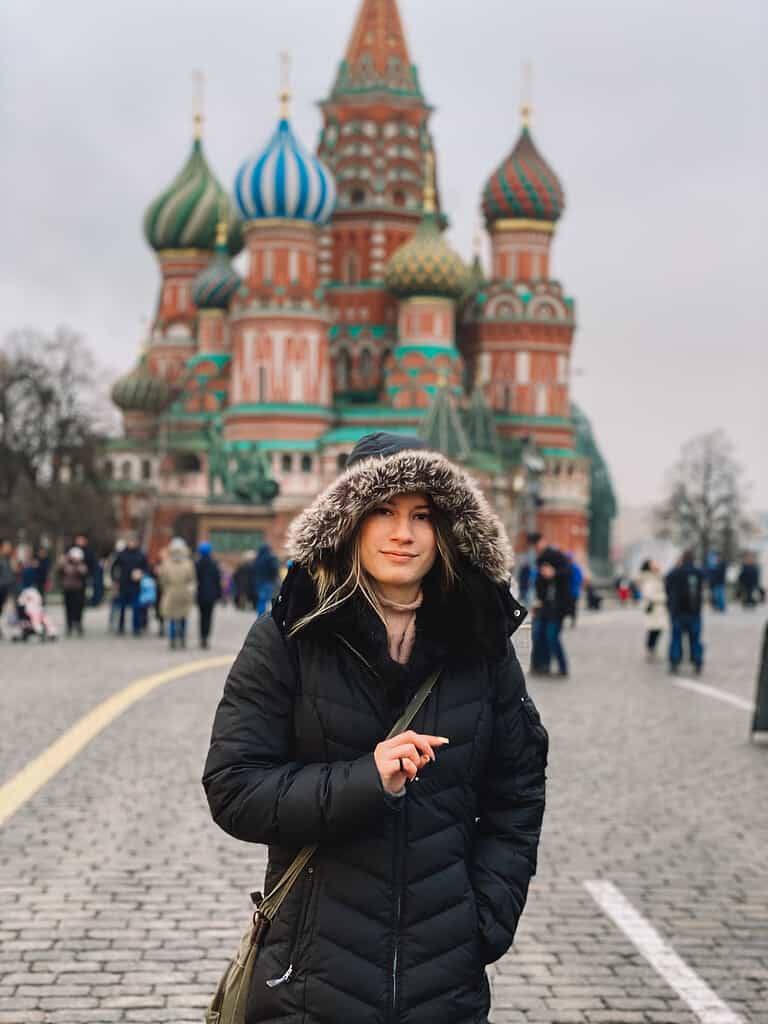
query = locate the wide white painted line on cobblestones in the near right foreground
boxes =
[584,882,745,1024]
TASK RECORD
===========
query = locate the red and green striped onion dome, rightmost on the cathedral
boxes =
[482,108,565,225]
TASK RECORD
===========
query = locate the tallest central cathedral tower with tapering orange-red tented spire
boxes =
[318,0,433,400]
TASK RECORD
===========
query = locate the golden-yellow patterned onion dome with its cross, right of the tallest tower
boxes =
[385,154,467,299]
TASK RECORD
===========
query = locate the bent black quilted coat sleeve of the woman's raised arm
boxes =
[203,616,392,846]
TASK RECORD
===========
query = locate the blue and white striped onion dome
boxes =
[234,118,336,224]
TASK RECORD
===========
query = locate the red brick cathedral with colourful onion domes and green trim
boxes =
[105,0,613,565]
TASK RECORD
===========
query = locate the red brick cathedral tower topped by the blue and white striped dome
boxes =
[224,81,336,451]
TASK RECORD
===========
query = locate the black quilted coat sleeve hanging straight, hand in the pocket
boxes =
[470,651,549,964]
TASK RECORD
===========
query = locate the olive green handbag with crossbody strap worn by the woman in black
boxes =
[205,669,442,1024]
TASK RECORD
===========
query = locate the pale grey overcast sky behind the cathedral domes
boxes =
[0,0,768,508]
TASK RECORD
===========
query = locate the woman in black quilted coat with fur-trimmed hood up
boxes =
[203,434,548,1024]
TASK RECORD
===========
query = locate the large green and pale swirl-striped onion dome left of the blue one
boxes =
[144,138,243,256]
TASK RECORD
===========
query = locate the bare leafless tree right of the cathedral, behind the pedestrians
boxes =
[655,430,751,559]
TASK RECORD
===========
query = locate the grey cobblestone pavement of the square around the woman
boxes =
[0,609,768,1024]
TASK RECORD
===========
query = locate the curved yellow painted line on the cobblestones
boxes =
[0,654,232,825]
